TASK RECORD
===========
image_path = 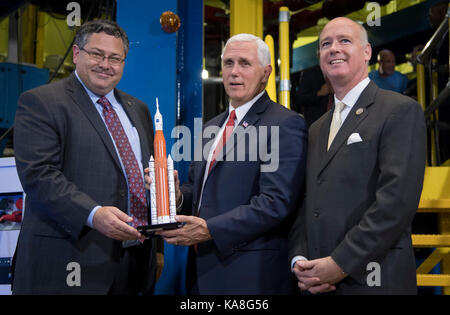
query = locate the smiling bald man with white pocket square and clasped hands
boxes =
[289,18,426,294]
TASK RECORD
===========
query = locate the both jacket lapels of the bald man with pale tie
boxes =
[319,82,378,174]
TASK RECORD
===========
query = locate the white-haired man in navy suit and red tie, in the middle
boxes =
[153,34,306,294]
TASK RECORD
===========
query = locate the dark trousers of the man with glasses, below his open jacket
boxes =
[108,240,156,295]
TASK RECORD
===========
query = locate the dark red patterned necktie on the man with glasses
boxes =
[97,96,148,227]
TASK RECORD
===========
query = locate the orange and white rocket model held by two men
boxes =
[149,98,176,228]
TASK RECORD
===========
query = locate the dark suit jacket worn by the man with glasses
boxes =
[13,74,155,294]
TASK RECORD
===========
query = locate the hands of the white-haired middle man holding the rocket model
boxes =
[144,168,211,246]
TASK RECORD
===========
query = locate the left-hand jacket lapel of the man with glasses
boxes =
[67,73,122,170]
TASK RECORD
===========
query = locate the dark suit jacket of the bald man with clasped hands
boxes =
[289,82,426,294]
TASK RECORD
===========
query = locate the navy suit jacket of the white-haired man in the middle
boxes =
[181,93,307,294]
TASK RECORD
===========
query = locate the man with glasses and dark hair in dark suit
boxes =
[13,21,160,294]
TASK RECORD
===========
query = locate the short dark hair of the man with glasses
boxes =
[74,20,130,56]
